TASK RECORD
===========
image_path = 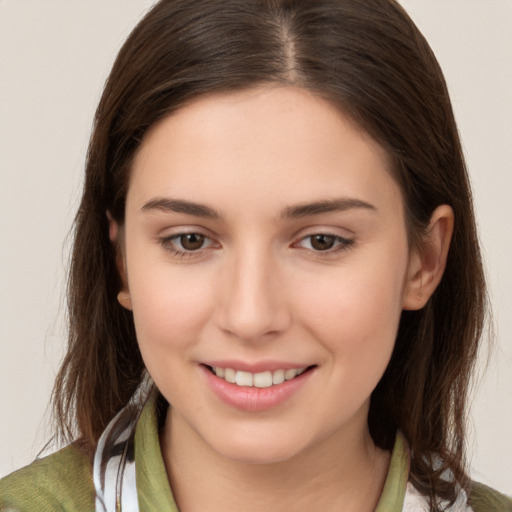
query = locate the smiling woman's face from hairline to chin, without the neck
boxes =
[120,86,420,462]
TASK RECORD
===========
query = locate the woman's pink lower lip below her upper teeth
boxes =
[201,366,313,412]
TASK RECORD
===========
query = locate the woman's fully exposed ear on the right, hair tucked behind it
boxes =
[403,204,454,310]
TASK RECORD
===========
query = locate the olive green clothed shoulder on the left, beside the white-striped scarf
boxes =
[0,444,94,512]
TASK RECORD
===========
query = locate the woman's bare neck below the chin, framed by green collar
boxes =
[162,410,389,512]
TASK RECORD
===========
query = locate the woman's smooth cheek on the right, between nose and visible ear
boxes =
[296,249,407,366]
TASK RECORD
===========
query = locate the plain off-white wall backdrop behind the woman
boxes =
[0,0,512,494]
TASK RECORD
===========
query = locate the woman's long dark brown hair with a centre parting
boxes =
[54,0,486,510]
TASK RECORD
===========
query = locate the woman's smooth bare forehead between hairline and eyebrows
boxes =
[128,86,401,216]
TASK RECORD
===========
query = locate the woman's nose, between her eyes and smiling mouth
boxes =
[219,246,291,342]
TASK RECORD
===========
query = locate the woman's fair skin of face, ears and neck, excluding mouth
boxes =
[111,86,453,511]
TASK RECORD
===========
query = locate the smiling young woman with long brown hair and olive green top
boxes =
[0,0,512,512]
